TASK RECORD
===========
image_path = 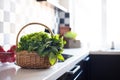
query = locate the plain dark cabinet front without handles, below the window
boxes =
[89,54,120,80]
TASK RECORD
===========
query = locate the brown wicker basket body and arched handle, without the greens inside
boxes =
[16,23,53,69]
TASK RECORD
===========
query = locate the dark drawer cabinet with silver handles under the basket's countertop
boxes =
[57,57,89,80]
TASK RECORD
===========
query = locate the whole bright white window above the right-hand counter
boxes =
[71,0,120,50]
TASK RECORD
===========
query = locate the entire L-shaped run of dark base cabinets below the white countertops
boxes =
[58,54,120,80]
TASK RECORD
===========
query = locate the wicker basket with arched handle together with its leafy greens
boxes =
[16,23,65,68]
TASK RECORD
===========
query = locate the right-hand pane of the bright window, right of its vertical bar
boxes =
[106,0,120,49]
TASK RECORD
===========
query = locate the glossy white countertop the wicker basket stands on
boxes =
[0,48,89,80]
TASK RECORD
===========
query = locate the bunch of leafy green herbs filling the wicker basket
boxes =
[17,32,66,65]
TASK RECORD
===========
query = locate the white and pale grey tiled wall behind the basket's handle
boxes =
[0,0,55,46]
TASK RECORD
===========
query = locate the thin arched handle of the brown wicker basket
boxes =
[16,22,54,46]
